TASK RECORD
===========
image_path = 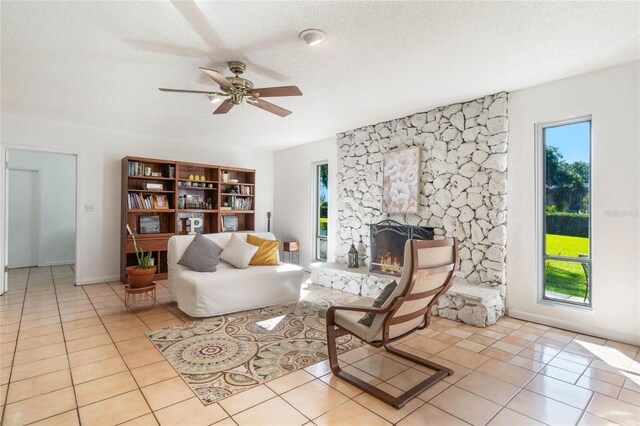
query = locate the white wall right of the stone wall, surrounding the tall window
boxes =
[507,62,640,344]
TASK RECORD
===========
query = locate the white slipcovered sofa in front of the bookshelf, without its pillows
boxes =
[167,232,304,317]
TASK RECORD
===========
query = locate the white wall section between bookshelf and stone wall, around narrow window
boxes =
[273,137,338,267]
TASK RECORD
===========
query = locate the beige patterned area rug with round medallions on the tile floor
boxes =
[147,299,364,404]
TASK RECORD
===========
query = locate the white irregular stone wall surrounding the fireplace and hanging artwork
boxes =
[336,92,509,295]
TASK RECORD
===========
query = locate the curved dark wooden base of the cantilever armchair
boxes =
[327,326,453,410]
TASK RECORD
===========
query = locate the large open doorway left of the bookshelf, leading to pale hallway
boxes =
[0,149,77,293]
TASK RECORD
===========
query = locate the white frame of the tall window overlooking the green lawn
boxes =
[535,115,594,310]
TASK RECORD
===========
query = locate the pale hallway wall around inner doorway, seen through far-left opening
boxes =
[9,150,76,266]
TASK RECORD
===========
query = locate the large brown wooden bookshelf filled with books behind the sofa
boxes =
[120,157,255,282]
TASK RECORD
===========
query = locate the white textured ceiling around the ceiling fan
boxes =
[1,1,640,149]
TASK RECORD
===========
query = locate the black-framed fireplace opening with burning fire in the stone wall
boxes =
[369,220,433,276]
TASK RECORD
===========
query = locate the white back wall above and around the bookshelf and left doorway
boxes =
[0,114,273,284]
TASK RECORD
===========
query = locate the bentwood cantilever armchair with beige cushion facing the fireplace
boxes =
[325,239,458,409]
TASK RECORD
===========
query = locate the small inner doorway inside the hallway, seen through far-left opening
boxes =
[7,169,40,269]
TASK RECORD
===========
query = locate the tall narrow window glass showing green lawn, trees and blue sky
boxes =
[537,118,593,306]
